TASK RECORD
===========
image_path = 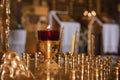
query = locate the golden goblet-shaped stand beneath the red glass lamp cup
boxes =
[37,40,60,73]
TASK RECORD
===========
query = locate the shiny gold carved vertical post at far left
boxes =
[1,0,10,52]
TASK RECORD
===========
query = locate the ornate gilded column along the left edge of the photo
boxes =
[0,0,10,64]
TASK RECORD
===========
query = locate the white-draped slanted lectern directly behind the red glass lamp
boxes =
[49,11,80,52]
